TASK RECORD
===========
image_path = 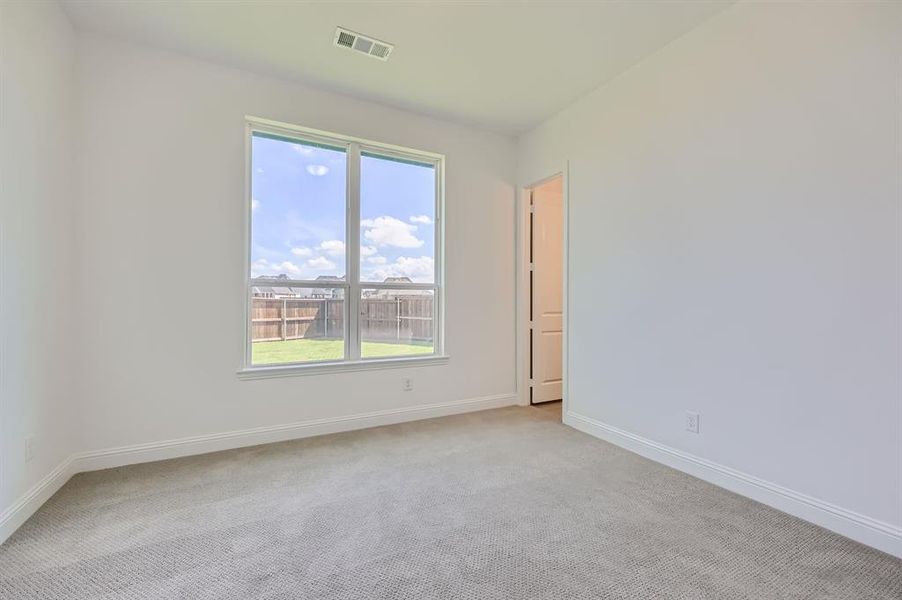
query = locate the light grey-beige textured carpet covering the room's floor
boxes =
[0,404,902,600]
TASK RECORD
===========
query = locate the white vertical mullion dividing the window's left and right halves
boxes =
[345,143,360,361]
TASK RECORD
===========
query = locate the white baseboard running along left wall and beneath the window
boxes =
[0,394,519,544]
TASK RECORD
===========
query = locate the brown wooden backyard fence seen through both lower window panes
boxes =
[251,296,435,342]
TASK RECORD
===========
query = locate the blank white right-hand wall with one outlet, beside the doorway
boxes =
[518,2,902,553]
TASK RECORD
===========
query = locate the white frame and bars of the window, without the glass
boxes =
[238,117,449,379]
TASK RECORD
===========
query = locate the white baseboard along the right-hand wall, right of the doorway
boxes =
[564,411,902,558]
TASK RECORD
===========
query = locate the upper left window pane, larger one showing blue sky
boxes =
[251,132,347,280]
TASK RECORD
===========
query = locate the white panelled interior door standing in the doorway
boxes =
[530,177,564,404]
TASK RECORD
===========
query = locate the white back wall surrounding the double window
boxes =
[77,36,516,450]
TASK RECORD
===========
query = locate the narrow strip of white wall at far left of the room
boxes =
[0,2,76,524]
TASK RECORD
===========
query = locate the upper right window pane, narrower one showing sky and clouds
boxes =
[360,152,435,283]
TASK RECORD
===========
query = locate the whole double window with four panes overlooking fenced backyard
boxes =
[246,119,443,370]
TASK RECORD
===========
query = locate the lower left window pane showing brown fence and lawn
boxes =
[251,288,345,365]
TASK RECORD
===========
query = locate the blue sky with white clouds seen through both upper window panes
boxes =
[251,136,435,282]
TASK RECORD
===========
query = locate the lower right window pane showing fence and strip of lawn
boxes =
[360,289,435,358]
